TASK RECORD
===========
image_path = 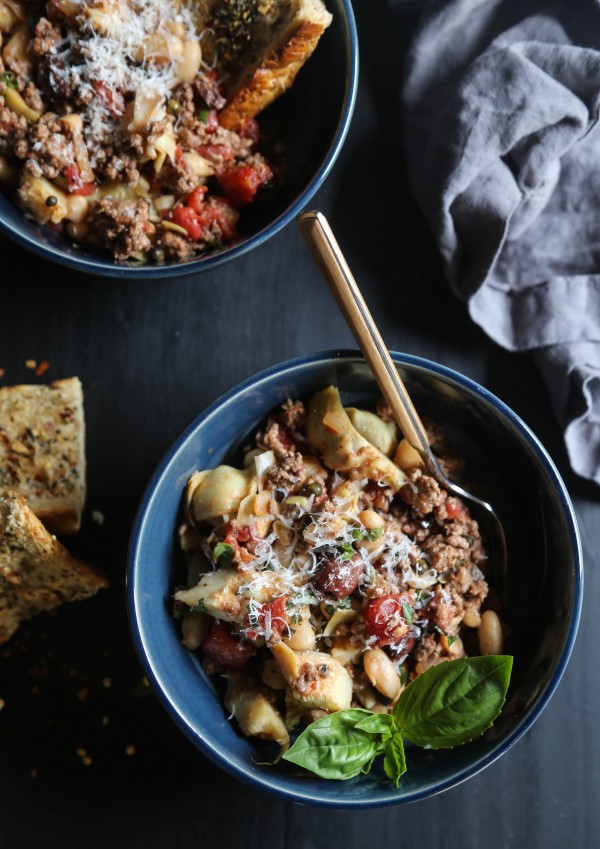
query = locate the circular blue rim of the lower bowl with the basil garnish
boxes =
[126,349,583,809]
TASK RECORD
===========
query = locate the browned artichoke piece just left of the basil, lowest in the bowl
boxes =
[225,675,290,757]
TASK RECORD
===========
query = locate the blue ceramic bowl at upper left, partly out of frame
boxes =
[0,0,358,278]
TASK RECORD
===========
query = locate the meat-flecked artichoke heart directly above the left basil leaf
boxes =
[271,642,352,712]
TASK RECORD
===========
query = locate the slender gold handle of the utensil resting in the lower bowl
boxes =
[298,212,430,457]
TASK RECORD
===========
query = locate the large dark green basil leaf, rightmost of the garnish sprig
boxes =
[393,655,512,749]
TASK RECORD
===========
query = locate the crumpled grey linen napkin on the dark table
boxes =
[403,0,600,483]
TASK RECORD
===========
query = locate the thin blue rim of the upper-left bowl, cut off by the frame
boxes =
[0,0,359,280]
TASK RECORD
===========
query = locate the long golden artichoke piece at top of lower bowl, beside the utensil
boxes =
[306,386,406,490]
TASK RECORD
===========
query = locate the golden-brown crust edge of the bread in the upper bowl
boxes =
[219,0,332,130]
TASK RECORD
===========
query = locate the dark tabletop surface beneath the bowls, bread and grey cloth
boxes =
[0,0,600,849]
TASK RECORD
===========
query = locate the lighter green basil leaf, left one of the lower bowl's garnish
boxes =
[283,708,381,780]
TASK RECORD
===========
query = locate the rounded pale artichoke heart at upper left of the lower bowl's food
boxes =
[186,466,256,524]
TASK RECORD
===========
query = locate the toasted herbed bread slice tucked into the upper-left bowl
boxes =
[202,0,332,130]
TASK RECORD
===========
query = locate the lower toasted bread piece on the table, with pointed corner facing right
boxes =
[0,493,108,643]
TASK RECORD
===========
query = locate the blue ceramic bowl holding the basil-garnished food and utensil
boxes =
[128,352,582,808]
